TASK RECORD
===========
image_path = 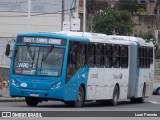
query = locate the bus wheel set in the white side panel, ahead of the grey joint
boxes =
[110,85,119,106]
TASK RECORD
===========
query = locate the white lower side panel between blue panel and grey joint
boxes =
[87,68,129,100]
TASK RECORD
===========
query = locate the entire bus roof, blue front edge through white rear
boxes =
[19,31,154,47]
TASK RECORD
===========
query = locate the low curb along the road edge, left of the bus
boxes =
[0,97,25,102]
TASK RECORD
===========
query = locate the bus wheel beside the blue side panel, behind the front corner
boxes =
[73,86,84,107]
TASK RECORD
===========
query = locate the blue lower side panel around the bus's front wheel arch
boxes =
[64,67,89,101]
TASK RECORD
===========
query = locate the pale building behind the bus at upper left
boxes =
[0,0,79,79]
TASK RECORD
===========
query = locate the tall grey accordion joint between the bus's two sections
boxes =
[127,43,138,98]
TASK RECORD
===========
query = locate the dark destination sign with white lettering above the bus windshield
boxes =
[18,37,65,45]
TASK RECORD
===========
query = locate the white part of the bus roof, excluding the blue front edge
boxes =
[54,31,154,47]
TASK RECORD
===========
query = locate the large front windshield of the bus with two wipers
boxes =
[13,44,64,77]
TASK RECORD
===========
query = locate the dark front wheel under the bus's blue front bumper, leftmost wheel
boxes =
[25,97,39,106]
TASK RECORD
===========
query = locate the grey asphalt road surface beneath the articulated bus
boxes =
[0,95,160,120]
